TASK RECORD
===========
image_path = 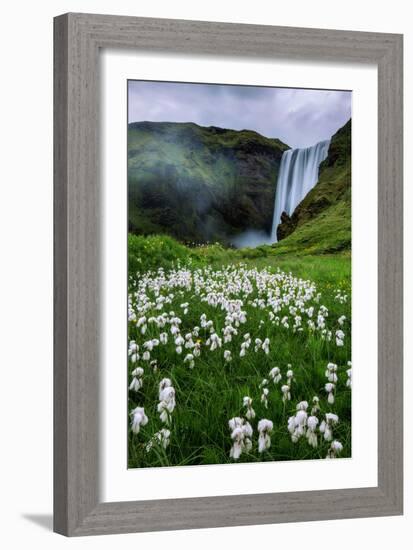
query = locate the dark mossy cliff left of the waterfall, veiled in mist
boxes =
[128,122,288,243]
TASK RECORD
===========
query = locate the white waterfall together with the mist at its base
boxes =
[232,139,330,248]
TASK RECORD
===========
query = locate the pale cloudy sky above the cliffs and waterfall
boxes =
[128,80,351,148]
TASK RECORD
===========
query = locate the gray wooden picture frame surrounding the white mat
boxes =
[54,14,403,536]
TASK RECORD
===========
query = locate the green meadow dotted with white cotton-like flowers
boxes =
[127,235,351,468]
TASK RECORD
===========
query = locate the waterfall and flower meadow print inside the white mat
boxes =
[126,80,352,468]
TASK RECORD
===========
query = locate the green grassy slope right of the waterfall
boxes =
[277,120,351,252]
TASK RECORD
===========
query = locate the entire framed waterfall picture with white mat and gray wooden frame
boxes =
[54,14,403,536]
